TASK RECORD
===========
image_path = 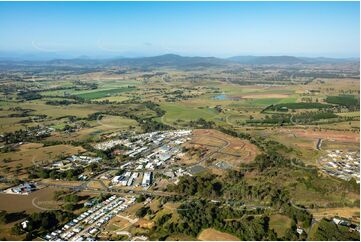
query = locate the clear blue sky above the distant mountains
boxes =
[0,2,360,57]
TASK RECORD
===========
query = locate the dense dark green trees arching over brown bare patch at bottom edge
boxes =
[153,200,277,240]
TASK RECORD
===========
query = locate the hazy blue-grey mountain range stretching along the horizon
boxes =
[0,54,359,68]
